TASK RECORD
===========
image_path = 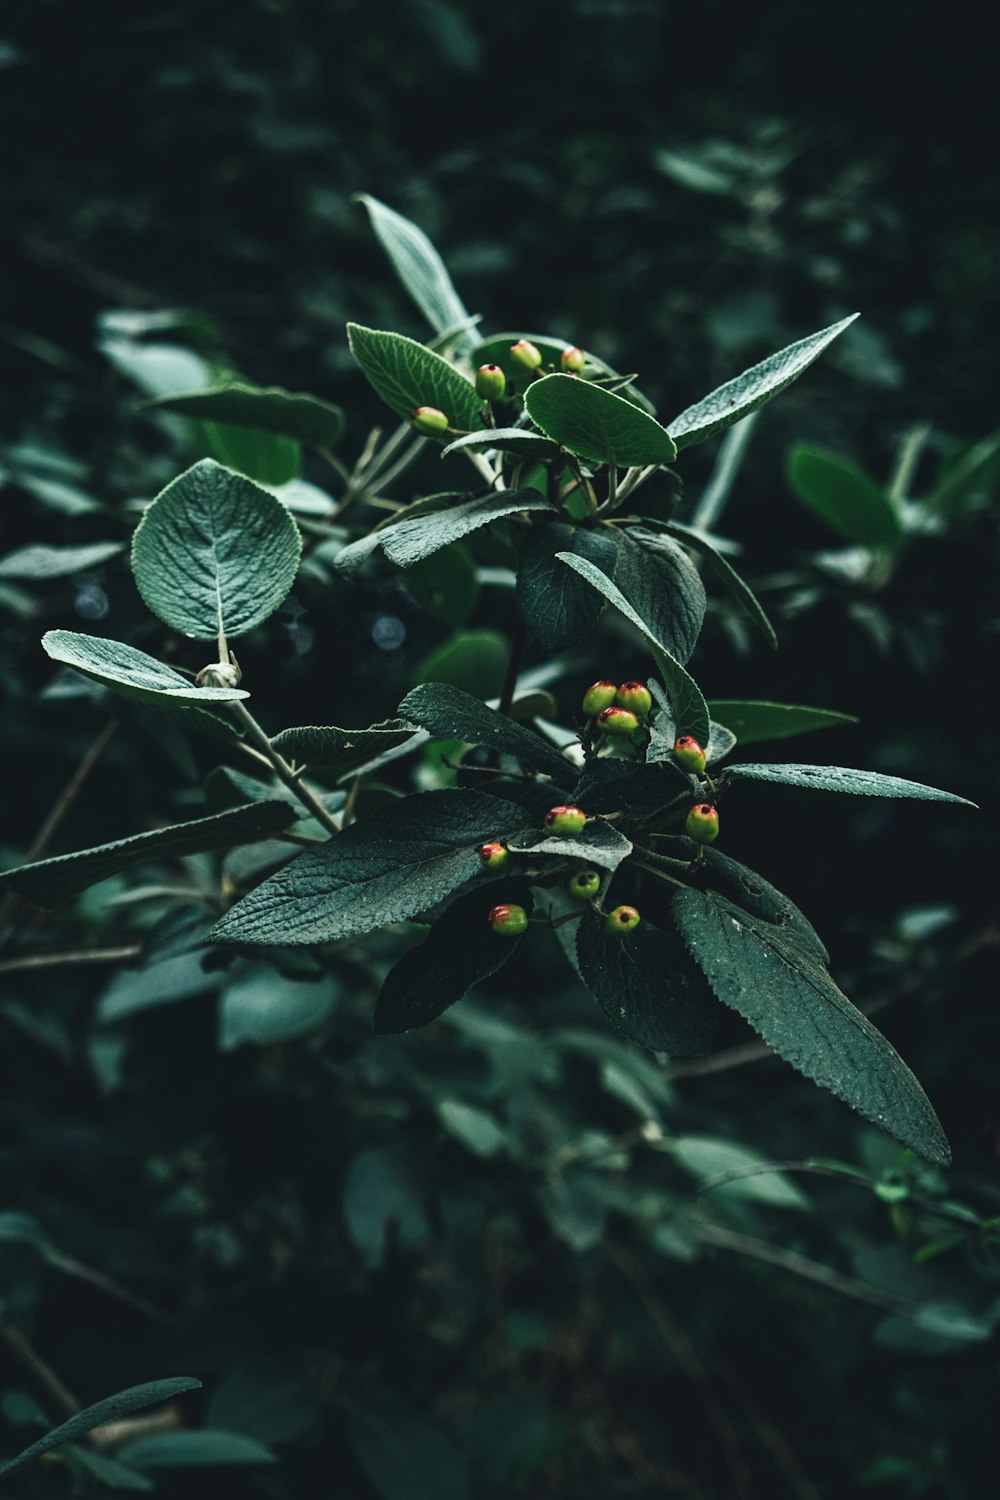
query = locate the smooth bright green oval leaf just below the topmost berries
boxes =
[525,375,678,468]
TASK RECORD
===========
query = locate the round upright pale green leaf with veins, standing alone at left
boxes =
[132,459,301,641]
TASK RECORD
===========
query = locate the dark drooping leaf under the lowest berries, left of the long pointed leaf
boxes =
[576,912,720,1058]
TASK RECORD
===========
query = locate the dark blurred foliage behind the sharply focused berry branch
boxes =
[0,0,1000,1500]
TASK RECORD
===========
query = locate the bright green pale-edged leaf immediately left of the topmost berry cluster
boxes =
[348,323,483,443]
